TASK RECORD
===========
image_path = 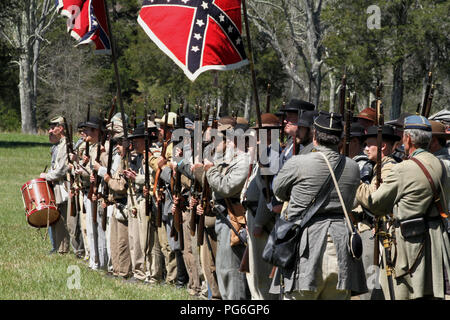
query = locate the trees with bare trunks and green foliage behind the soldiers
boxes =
[0,0,450,133]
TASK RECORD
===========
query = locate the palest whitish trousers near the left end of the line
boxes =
[84,195,108,270]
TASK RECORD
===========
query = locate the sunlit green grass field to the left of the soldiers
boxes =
[0,133,190,300]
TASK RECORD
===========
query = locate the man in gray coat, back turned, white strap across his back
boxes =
[270,112,367,300]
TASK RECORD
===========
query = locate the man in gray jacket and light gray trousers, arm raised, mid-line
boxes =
[197,117,250,300]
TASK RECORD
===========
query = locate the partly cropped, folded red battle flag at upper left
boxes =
[56,0,111,54]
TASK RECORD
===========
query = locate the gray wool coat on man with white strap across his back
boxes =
[270,146,367,295]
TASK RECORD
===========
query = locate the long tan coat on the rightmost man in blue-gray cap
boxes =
[367,149,450,299]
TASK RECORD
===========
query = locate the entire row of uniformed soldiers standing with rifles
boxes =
[41,99,450,300]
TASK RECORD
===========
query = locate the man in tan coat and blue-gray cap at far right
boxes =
[367,116,450,300]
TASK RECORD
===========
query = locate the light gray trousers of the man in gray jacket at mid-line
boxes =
[215,218,250,300]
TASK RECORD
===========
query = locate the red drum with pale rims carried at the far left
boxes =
[20,178,60,228]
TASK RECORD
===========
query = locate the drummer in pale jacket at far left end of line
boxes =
[40,116,69,254]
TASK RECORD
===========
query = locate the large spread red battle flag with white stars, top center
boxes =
[138,0,248,81]
